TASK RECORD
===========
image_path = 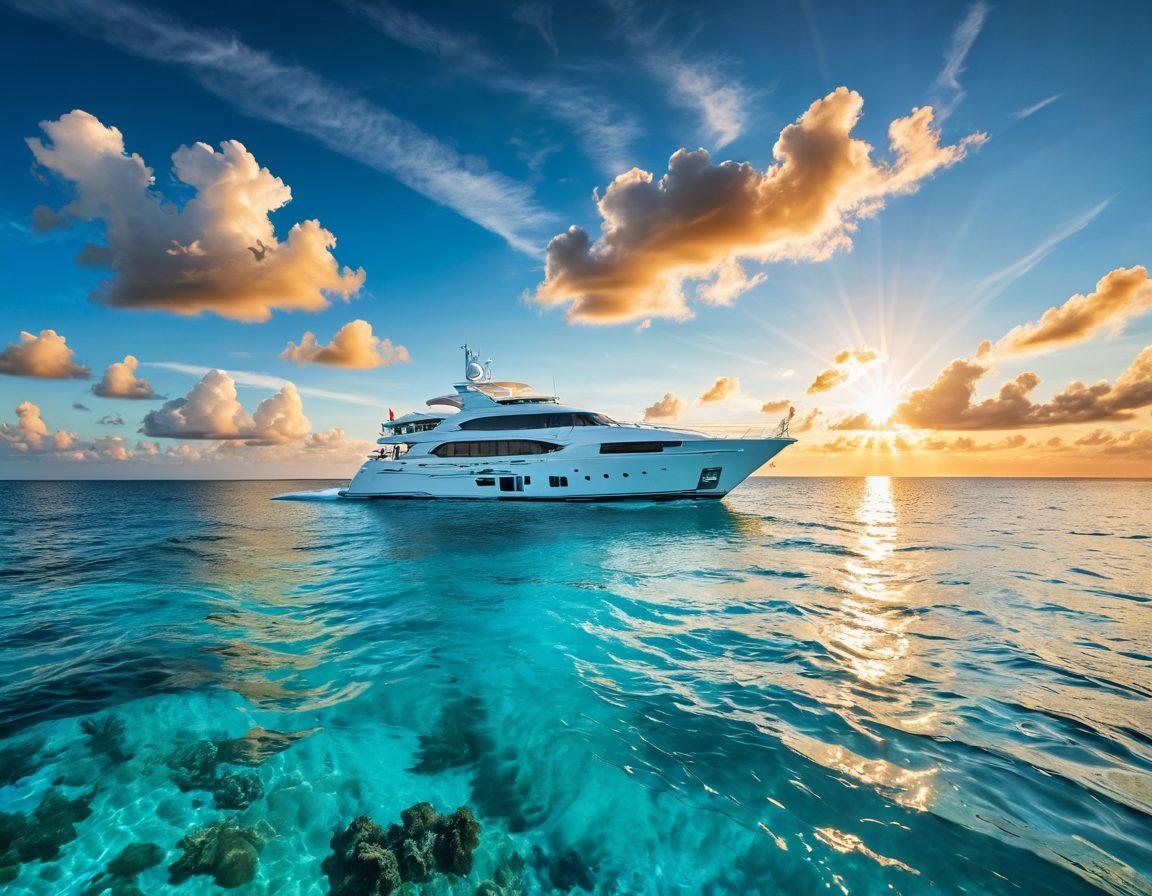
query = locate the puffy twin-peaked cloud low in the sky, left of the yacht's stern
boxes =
[141,370,311,446]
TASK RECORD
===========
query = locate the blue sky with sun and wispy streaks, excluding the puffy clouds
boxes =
[0,0,1152,474]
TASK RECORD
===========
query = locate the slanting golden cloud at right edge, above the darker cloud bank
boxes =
[994,265,1152,354]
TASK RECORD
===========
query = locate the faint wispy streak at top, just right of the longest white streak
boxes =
[344,0,639,172]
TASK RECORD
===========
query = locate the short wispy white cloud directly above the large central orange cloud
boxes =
[608,0,752,149]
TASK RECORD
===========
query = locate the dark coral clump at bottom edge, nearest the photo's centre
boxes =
[323,803,480,896]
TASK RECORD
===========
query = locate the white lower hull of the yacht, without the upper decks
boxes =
[340,438,795,501]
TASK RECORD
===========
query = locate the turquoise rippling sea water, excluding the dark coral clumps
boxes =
[0,478,1152,896]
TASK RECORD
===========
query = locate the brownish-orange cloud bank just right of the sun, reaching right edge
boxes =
[893,346,1152,430]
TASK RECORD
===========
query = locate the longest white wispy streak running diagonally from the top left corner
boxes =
[6,0,551,253]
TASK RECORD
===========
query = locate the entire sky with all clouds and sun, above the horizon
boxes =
[0,0,1152,479]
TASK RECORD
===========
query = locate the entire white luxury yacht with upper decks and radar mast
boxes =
[340,346,796,501]
